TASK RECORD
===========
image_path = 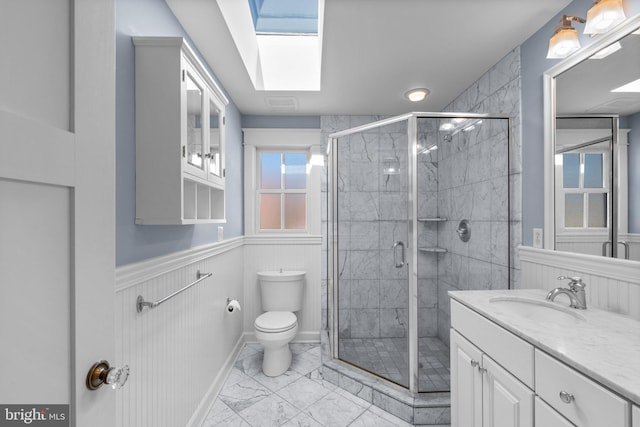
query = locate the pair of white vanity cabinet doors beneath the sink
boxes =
[451,330,534,427]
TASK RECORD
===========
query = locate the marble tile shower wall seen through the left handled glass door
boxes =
[323,117,408,338]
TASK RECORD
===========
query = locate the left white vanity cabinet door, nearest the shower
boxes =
[450,329,482,427]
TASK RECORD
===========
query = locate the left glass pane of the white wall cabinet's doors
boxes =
[183,72,205,173]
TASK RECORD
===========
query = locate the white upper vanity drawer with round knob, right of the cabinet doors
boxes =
[535,350,631,427]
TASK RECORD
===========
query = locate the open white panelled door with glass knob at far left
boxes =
[0,0,116,427]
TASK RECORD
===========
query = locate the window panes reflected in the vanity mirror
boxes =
[558,152,610,230]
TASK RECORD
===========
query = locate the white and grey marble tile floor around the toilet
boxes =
[201,344,430,427]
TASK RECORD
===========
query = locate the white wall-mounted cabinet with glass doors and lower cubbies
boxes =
[133,37,229,224]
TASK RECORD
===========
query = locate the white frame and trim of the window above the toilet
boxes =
[243,128,324,236]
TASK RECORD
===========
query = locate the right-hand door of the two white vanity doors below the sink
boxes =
[482,355,534,427]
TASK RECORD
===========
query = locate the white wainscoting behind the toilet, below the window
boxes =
[242,236,322,342]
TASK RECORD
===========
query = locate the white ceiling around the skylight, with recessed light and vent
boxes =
[166,0,571,115]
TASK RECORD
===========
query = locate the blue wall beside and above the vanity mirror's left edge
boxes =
[520,0,640,246]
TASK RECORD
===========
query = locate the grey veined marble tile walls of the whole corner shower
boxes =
[321,47,522,343]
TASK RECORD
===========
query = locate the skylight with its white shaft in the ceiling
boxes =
[217,0,324,91]
